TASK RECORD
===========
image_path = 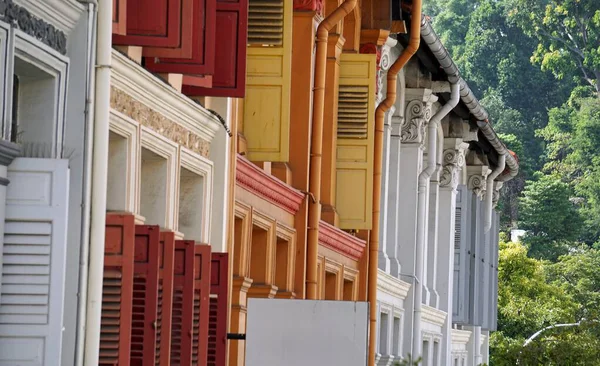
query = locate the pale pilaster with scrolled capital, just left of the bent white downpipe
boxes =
[397,89,435,352]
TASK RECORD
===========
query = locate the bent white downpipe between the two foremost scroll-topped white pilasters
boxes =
[412,83,460,358]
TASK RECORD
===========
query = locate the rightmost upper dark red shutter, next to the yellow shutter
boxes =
[183,0,248,98]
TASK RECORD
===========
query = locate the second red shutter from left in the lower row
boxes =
[130,225,160,366]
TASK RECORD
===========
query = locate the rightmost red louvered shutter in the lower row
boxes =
[208,253,229,366]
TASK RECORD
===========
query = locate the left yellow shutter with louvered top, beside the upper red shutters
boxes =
[242,0,293,162]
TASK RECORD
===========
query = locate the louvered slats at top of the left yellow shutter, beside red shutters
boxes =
[248,0,283,46]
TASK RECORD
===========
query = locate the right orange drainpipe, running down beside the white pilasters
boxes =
[368,0,421,366]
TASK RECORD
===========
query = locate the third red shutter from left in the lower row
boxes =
[155,232,175,366]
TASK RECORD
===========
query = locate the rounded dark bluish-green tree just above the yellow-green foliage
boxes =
[519,175,581,261]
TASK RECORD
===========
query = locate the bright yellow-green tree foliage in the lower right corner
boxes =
[490,243,600,366]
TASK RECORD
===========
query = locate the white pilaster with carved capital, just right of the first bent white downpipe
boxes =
[436,138,469,366]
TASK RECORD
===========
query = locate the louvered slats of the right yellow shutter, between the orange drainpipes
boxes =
[338,85,369,139]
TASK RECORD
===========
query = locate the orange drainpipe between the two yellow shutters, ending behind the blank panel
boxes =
[306,0,357,300]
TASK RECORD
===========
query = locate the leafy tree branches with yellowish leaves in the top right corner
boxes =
[508,0,600,92]
